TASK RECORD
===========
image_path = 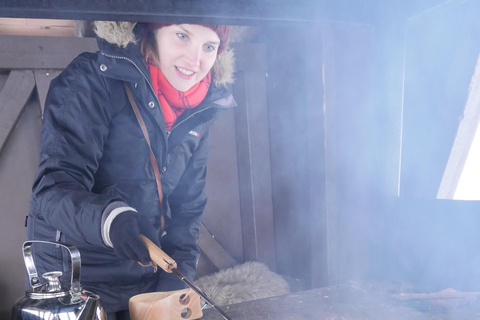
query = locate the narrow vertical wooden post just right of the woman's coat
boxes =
[234,71,276,270]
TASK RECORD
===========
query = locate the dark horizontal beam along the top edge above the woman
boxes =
[0,0,322,25]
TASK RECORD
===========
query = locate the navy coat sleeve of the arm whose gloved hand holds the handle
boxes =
[30,54,120,246]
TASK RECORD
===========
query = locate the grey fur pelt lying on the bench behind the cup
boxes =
[194,262,290,306]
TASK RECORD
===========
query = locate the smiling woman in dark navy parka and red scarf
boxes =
[27,22,235,320]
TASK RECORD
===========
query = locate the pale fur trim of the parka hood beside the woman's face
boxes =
[93,21,235,86]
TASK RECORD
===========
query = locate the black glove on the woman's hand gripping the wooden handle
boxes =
[110,211,160,265]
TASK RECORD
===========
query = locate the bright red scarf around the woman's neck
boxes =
[147,61,211,131]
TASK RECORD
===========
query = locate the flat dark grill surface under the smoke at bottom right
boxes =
[202,283,480,320]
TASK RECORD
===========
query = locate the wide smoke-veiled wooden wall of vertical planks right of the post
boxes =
[267,23,374,287]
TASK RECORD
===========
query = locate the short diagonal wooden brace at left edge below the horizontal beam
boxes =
[0,70,35,152]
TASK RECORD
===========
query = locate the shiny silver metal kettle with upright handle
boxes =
[12,241,107,320]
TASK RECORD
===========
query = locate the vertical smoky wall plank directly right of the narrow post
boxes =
[266,26,321,284]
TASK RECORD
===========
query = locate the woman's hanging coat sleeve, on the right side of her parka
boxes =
[157,131,209,291]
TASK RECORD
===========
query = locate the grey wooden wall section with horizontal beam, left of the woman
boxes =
[0,35,96,319]
